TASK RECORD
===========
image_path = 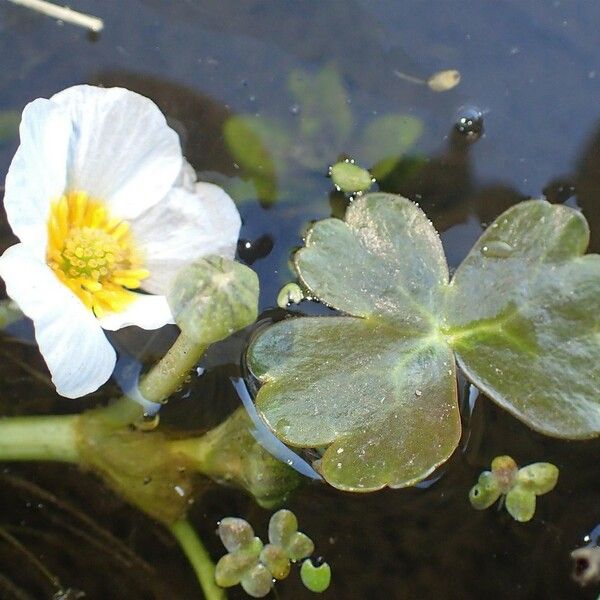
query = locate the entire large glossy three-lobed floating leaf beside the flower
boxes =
[248,194,600,491]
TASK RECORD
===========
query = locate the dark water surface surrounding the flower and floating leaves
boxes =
[0,0,600,599]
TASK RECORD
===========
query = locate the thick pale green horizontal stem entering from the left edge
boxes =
[0,415,80,463]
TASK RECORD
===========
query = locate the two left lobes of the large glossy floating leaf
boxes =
[250,194,460,491]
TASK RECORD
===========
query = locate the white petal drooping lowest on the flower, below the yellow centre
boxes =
[0,244,115,398]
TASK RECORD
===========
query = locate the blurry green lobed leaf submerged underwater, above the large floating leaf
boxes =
[218,64,423,204]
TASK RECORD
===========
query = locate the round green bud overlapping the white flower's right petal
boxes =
[167,256,258,346]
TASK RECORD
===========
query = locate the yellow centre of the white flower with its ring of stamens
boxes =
[46,192,149,317]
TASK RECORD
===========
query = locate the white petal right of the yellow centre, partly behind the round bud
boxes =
[131,183,241,294]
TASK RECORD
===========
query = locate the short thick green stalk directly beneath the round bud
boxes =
[140,331,207,402]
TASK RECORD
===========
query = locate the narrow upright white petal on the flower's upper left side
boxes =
[4,99,72,259]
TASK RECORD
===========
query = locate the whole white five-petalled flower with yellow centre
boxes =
[0,86,240,398]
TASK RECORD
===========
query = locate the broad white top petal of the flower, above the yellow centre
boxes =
[51,85,183,219]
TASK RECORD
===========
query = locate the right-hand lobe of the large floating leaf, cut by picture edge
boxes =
[446,200,600,438]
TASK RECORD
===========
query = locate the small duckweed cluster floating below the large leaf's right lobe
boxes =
[469,456,558,522]
